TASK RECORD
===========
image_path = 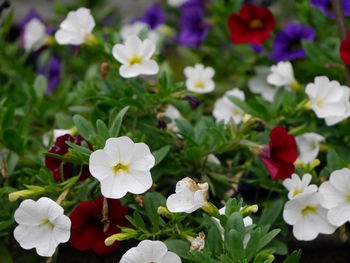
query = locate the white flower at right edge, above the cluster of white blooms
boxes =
[305,76,350,125]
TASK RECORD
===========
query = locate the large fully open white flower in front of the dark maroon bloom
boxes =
[89,136,155,199]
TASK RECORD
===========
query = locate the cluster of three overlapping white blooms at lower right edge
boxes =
[283,168,350,241]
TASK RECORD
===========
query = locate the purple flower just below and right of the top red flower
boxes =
[271,24,315,62]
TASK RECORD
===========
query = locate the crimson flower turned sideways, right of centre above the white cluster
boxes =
[259,126,298,181]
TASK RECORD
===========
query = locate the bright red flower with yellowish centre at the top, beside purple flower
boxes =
[228,4,275,44]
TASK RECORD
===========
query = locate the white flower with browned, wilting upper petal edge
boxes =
[166,177,208,213]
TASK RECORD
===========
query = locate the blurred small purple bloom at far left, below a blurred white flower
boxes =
[39,56,61,94]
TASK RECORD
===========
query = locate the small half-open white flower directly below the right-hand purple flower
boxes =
[267,61,296,88]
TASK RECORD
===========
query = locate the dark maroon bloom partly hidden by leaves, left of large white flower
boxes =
[45,134,91,182]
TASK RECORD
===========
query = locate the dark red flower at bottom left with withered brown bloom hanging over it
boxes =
[69,196,129,254]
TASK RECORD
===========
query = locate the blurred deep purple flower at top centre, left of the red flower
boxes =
[177,4,210,48]
